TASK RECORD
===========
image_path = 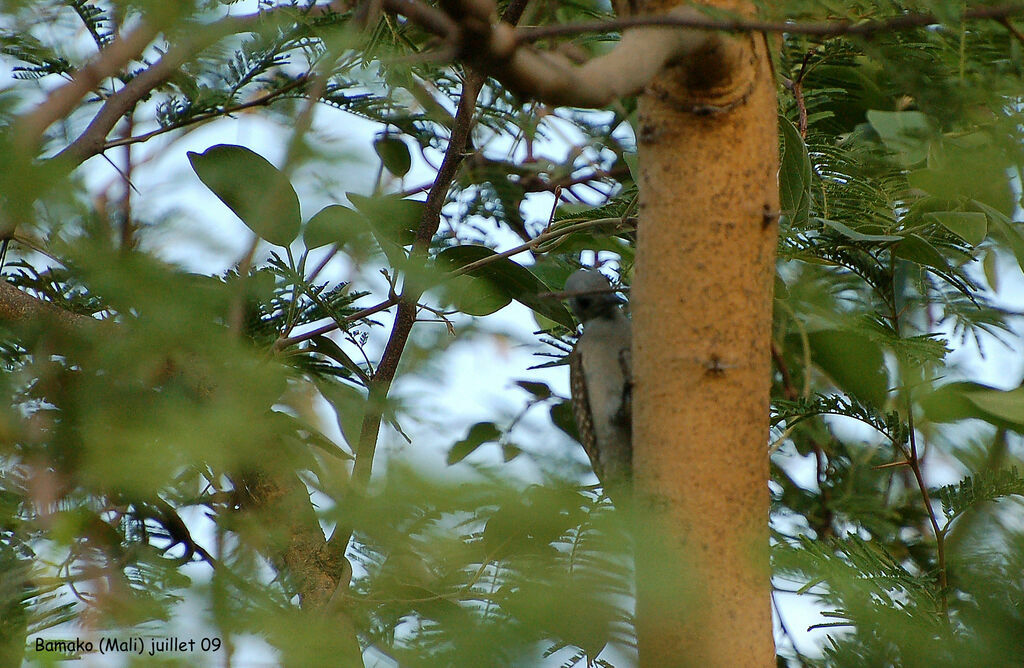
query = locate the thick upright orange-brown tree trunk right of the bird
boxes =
[631,1,778,667]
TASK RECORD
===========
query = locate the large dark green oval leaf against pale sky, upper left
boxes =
[188,143,301,246]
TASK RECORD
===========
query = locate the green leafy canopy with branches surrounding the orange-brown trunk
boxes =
[0,0,1024,666]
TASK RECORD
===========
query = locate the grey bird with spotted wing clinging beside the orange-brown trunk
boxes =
[565,269,633,506]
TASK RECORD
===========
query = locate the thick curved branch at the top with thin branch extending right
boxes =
[374,0,1024,108]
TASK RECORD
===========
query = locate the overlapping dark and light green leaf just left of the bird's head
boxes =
[436,244,574,328]
